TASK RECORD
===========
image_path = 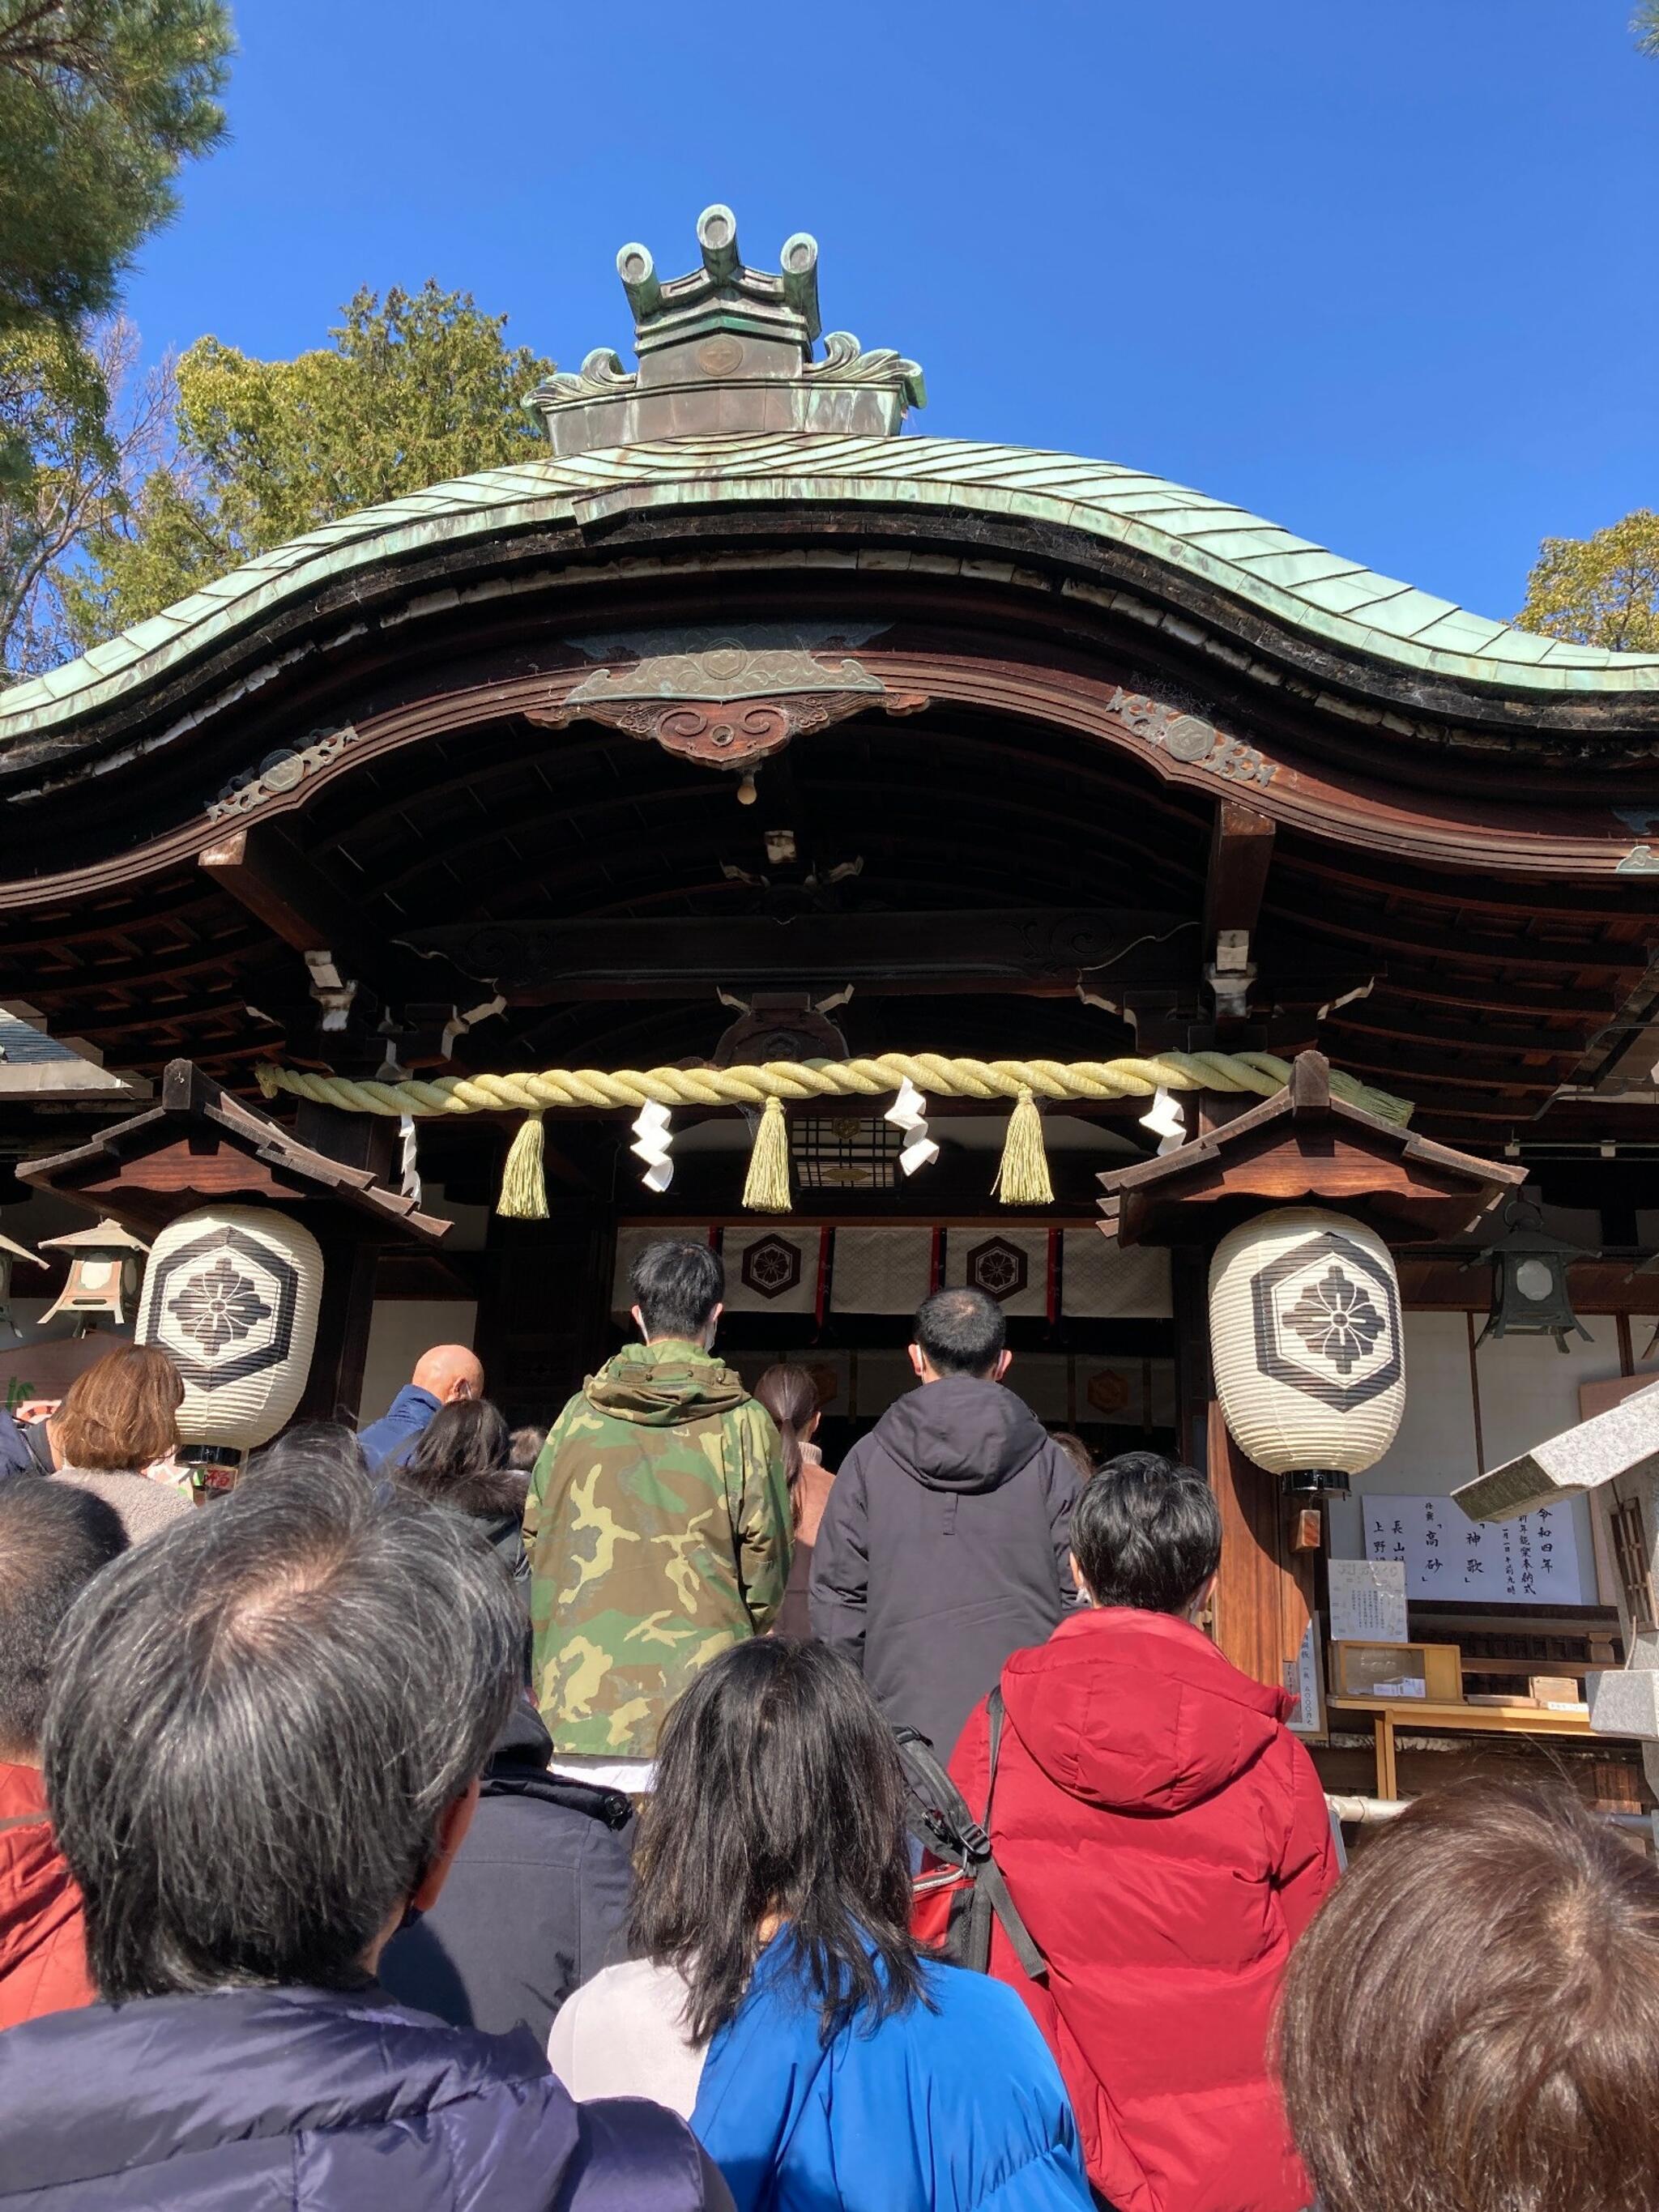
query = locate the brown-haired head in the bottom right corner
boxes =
[1278,1780,1659,2212]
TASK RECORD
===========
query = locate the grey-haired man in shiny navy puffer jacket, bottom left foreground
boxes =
[0,1471,730,2212]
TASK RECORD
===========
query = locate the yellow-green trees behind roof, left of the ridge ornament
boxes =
[69,279,551,646]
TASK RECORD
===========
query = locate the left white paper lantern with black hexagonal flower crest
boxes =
[137,1205,323,1451]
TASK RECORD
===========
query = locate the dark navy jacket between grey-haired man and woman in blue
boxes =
[381,1698,633,2046]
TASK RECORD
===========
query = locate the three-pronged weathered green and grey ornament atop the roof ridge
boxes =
[524,206,927,456]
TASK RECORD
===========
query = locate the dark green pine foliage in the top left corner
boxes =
[0,0,232,334]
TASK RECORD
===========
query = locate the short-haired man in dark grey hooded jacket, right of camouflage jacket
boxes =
[812,1289,1077,1758]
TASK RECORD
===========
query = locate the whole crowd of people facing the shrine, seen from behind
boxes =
[0,1238,1659,2212]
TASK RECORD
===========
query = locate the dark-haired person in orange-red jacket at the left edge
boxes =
[0,1482,126,2028]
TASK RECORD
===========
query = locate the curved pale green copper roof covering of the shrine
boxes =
[0,432,1659,744]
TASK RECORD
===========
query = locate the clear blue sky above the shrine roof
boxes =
[128,0,1659,615]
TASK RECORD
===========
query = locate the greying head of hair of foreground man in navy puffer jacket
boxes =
[45,1468,524,2002]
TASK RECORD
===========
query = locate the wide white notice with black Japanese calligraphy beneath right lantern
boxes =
[1363,1495,1595,1606]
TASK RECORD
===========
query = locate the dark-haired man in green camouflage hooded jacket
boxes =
[524,1243,794,1788]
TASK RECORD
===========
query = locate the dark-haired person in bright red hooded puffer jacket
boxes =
[951,1451,1336,2212]
